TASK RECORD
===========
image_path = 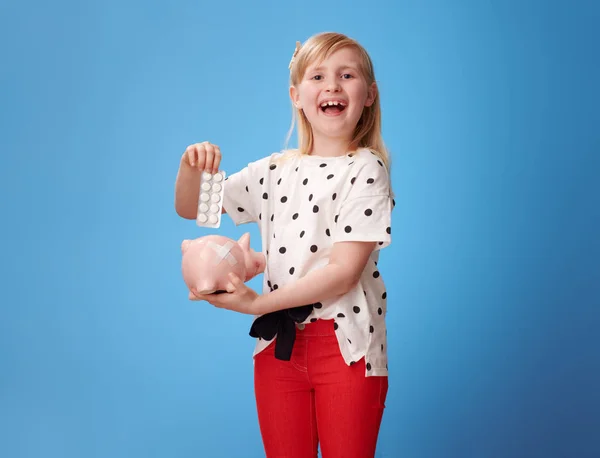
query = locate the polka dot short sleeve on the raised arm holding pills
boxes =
[223,157,270,226]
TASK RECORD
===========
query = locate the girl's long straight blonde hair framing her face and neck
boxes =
[286,32,391,171]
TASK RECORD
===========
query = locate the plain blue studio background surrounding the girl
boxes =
[0,0,600,458]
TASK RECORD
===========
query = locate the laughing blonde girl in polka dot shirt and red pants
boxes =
[175,33,393,458]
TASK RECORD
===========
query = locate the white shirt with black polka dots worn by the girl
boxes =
[224,149,394,376]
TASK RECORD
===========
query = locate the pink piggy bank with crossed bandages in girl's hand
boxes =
[181,233,266,295]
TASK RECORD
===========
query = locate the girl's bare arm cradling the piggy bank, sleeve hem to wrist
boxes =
[254,242,375,315]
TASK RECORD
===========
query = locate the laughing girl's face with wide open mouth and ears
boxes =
[290,47,377,147]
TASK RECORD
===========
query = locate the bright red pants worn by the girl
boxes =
[254,320,388,458]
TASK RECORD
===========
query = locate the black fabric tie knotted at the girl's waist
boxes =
[250,304,313,361]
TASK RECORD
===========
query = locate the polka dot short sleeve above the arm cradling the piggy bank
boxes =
[332,157,393,249]
